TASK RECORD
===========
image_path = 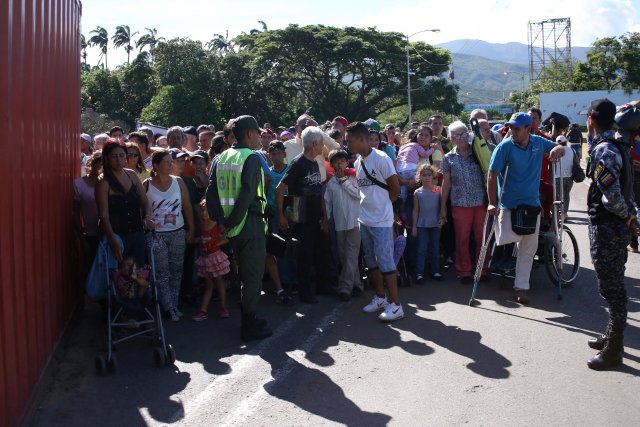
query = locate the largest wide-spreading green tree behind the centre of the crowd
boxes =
[234,25,462,120]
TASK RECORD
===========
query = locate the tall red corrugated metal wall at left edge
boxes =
[0,0,81,426]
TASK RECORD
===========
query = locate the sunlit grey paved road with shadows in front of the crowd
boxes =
[31,179,640,426]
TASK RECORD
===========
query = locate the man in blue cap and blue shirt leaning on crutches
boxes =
[487,113,564,304]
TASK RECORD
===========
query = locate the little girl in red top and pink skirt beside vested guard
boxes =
[192,200,230,322]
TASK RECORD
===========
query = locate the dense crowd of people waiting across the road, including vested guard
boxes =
[74,102,640,370]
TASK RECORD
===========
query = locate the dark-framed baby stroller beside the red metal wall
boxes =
[87,233,176,375]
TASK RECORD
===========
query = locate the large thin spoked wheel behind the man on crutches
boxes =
[544,226,580,286]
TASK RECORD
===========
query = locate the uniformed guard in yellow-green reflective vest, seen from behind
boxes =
[206,116,272,341]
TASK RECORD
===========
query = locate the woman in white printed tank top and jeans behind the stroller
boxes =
[144,150,194,321]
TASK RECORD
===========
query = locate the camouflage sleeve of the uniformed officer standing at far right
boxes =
[593,144,629,218]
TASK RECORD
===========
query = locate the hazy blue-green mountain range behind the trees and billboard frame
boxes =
[436,39,590,104]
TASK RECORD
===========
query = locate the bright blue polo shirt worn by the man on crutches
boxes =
[489,135,555,209]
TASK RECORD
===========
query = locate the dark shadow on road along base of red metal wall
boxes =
[30,302,191,427]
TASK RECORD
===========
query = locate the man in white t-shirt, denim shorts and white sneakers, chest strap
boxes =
[346,122,404,322]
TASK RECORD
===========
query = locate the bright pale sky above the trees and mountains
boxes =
[82,0,640,68]
